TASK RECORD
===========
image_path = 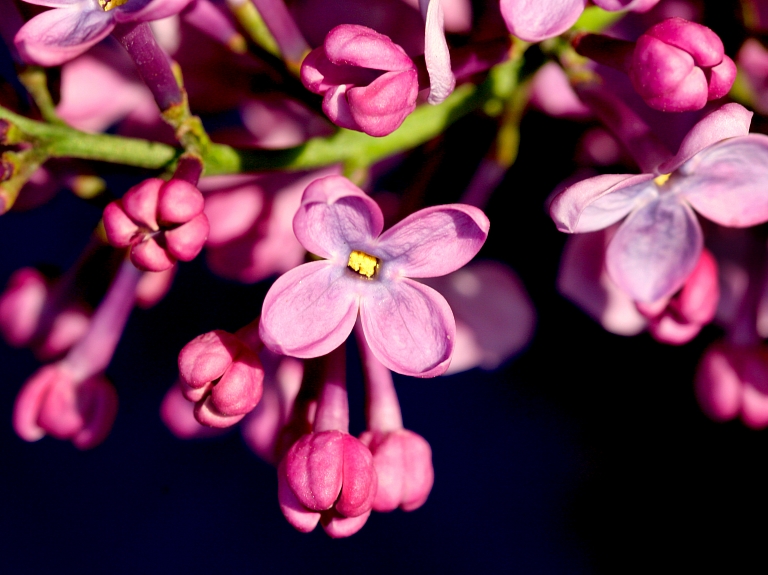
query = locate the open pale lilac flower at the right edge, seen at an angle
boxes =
[550,104,768,303]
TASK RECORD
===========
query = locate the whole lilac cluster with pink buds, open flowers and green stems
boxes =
[10,0,768,552]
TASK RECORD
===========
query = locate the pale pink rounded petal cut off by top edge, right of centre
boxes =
[500,0,587,42]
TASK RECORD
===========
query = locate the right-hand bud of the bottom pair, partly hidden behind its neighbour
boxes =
[360,429,435,511]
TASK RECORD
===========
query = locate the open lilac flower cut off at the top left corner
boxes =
[15,0,192,66]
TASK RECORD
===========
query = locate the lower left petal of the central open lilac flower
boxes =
[259,261,362,358]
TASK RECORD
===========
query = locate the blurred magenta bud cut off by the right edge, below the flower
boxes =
[695,343,768,429]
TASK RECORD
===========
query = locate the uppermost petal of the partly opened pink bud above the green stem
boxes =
[323,24,414,71]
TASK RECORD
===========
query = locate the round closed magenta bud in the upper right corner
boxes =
[628,18,736,112]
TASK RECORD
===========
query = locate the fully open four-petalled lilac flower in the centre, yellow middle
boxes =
[260,176,490,377]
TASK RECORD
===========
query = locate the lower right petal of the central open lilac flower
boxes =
[360,278,456,377]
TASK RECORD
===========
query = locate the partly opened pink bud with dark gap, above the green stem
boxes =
[301,24,419,136]
